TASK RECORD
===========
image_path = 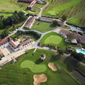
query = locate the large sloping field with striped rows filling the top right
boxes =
[42,0,85,27]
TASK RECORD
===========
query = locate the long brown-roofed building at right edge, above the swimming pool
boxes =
[59,29,85,44]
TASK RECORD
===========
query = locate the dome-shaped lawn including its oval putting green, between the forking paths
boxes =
[40,32,76,49]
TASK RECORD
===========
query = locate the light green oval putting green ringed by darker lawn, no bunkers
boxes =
[44,35,62,44]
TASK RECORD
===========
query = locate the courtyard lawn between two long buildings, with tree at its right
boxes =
[32,21,57,32]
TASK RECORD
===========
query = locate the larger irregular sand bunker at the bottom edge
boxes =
[33,74,47,85]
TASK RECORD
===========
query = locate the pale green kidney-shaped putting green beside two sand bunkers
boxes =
[20,60,46,73]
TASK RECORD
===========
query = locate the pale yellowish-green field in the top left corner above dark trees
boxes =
[0,0,29,12]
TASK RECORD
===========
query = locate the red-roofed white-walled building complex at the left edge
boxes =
[0,37,33,51]
